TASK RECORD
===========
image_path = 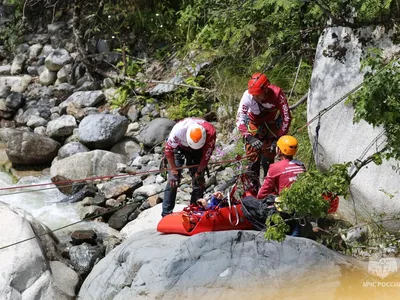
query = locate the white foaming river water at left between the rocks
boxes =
[0,172,80,229]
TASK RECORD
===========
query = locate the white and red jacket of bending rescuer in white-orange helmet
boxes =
[165,118,216,172]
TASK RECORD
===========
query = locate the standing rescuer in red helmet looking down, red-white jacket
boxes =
[236,73,292,189]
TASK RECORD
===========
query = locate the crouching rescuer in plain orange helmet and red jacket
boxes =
[257,135,306,199]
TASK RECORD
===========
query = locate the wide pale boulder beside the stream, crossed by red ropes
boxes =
[50,150,128,194]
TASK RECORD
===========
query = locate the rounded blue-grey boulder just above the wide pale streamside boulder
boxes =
[79,114,129,149]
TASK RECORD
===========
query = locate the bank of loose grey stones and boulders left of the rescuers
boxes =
[0,8,244,288]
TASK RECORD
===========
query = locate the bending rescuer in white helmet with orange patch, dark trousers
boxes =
[161,118,216,217]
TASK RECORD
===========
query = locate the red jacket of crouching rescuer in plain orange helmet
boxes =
[257,159,306,199]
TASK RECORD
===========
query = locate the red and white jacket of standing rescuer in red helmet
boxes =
[236,85,292,137]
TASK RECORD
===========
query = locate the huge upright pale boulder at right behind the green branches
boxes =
[307,27,400,228]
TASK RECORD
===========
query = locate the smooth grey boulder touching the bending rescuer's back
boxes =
[137,118,176,147]
